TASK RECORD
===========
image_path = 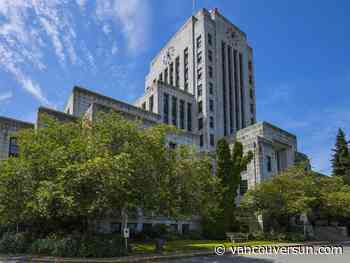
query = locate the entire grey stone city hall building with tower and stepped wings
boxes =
[0,6,307,231]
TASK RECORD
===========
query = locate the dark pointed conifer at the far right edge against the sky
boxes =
[332,129,350,185]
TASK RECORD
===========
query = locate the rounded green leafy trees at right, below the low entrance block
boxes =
[242,165,350,231]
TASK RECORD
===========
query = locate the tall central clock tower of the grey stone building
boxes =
[136,9,256,151]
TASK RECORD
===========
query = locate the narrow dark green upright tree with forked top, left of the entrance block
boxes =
[205,139,253,238]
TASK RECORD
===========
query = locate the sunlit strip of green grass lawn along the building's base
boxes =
[132,240,279,254]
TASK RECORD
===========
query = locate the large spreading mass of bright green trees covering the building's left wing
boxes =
[0,113,218,232]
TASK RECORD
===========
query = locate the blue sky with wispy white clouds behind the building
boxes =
[0,0,350,173]
